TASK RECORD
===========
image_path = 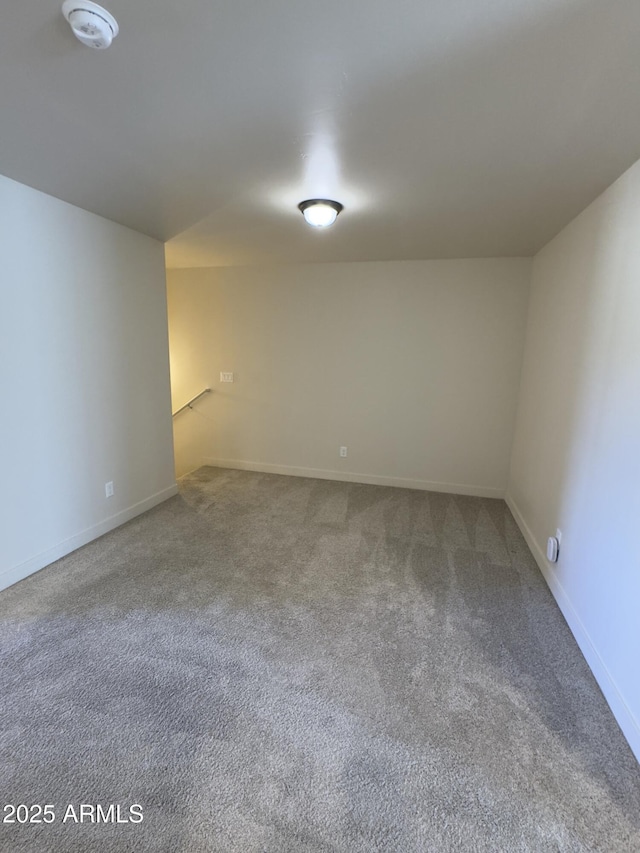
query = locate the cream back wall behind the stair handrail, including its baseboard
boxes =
[168,259,531,496]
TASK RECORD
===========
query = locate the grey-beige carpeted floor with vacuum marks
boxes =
[0,468,640,853]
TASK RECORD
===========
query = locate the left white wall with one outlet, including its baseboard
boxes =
[0,177,175,588]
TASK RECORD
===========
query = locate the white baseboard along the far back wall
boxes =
[202,457,504,498]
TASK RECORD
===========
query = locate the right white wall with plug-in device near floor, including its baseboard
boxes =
[508,158,640,758]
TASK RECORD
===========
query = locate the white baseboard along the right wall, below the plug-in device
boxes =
[505,493,640,761]
